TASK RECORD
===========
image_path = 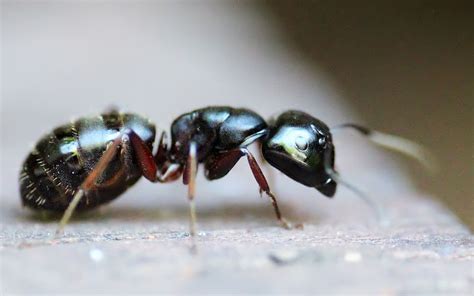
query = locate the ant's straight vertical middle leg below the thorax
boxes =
[183,142,198,237]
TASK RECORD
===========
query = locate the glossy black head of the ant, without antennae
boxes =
[262,111,336,197]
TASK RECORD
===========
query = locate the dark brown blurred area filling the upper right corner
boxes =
[262,1,474,229]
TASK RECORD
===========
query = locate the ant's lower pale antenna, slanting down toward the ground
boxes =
[323,144,389,226]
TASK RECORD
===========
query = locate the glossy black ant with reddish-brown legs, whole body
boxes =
[20,106,432,236]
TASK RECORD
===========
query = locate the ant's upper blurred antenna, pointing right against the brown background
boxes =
[331,123,438,174]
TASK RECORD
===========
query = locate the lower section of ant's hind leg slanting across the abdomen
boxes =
[56,137,122,236]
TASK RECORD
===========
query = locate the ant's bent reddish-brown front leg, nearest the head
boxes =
[206,148,291,229]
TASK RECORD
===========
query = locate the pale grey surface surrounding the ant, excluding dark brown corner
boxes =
[0,1,474,294]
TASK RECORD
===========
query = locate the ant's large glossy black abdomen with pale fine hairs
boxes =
[20,111,155,212]
